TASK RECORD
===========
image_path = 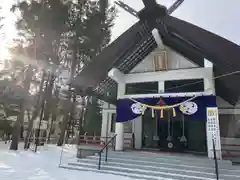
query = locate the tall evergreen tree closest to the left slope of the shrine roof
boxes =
[58,0,116,145]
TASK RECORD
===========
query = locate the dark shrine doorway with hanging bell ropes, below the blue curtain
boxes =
[142,111,207,153]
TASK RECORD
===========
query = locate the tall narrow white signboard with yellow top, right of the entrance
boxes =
[206,107,222,159]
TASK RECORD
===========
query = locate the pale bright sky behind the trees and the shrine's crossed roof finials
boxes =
[0,0,240,61]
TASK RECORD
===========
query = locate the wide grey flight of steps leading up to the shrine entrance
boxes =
[61,151,240,180]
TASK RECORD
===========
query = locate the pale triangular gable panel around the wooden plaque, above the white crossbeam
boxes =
[130,46,199,73]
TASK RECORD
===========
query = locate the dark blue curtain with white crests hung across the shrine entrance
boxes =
[116,96,216,122]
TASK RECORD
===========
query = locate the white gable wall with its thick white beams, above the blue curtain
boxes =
[114,44,215,98]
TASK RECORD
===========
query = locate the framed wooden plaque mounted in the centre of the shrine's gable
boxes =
[153,51,167,71]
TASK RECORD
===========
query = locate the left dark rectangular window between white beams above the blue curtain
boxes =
[125,82,158,95]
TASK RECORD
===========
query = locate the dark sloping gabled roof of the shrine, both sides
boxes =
[74,15,240,104]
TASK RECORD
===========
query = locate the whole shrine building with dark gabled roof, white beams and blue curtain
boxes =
[71,1,240,158]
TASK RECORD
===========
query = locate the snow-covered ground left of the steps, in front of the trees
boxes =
[0,142,139,180]
